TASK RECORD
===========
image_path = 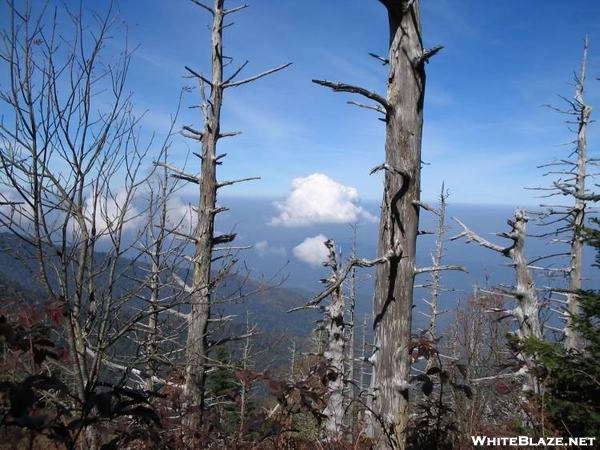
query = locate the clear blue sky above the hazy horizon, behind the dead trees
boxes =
[3,0,600,206]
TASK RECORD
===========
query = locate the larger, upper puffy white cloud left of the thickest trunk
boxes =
[269,173,376,227]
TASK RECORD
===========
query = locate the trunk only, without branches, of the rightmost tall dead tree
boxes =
[565,37,592,351]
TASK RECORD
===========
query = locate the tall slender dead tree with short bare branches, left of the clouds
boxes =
[156,0,290,430]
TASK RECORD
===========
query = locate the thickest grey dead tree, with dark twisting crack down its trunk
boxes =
[313,0,441,448]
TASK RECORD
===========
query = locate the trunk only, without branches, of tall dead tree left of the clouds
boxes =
[184,0,224,430]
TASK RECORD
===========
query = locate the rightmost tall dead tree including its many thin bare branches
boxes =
[534,36,600,351]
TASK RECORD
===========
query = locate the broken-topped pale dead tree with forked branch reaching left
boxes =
[451,209,543,393]
